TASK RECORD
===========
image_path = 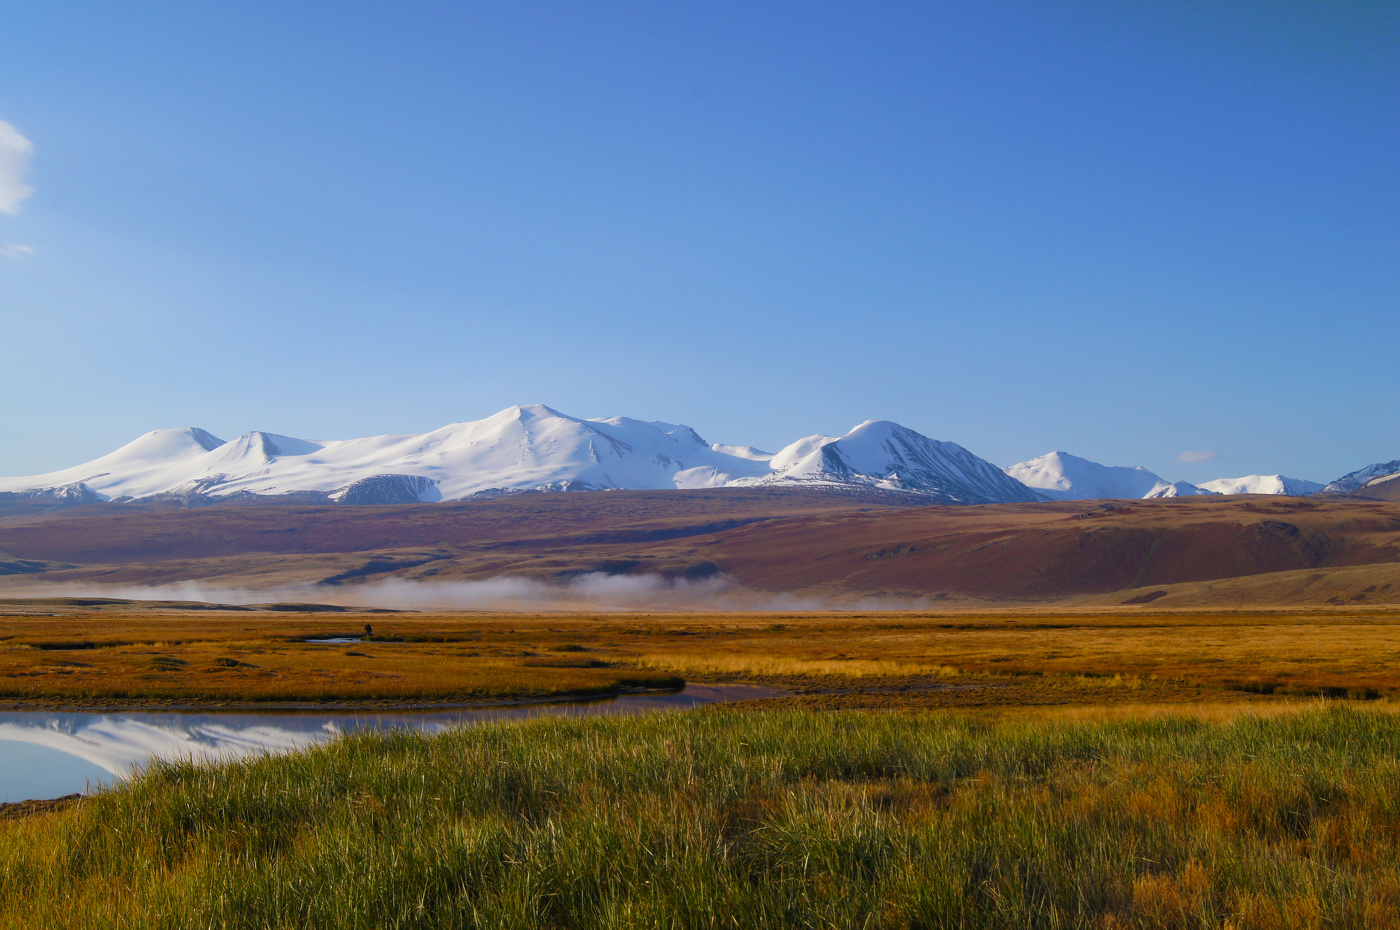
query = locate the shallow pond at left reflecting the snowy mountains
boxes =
[0,685,781,801]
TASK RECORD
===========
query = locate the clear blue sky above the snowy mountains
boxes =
[0,0,1400,482]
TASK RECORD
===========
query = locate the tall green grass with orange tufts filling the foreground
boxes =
[0,706,1400,927]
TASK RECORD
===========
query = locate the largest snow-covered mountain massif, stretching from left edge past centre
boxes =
[0,405,1035,503]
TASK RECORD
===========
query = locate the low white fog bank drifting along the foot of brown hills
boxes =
[0,573,930,611]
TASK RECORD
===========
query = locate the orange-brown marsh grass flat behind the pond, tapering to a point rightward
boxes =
[0,615,678,705]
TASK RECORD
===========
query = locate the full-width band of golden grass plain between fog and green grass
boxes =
[0,608,1400,706]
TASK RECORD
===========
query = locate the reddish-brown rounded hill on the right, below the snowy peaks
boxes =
[705,497,1400,598]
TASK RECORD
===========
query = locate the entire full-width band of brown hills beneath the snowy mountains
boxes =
[0,490,1400,606]
